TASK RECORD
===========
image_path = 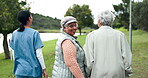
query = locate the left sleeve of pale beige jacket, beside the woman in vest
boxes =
[83,34,94,76]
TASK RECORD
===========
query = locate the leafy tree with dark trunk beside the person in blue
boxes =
[0,0,27,59]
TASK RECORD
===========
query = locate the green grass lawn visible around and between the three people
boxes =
[0,28,148,78]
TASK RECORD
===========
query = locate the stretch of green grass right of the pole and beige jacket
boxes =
[131,30,148,78]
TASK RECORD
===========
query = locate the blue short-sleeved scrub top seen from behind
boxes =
[10,28,44,77]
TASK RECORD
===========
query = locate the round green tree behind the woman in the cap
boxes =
[65,4,93,35]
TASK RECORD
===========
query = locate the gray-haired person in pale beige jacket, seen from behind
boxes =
[84,11,132,78]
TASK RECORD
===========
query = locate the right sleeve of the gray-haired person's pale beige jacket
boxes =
[121,34,132,77]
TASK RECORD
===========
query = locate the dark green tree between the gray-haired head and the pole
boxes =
[113,0,130,29]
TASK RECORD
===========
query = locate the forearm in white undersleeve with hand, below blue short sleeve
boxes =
[36,48,48,78]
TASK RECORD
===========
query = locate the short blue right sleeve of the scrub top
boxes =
[34,31,44,50]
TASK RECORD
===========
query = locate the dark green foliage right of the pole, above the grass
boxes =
[132,0,148,31]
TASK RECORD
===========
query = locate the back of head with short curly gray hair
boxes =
[98,10,114,26]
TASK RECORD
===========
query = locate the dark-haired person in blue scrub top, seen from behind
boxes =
[10,10,48,78]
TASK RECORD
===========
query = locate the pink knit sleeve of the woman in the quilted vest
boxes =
[62,40,84,78]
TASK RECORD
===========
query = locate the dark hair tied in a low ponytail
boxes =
[17,10,31,32]
